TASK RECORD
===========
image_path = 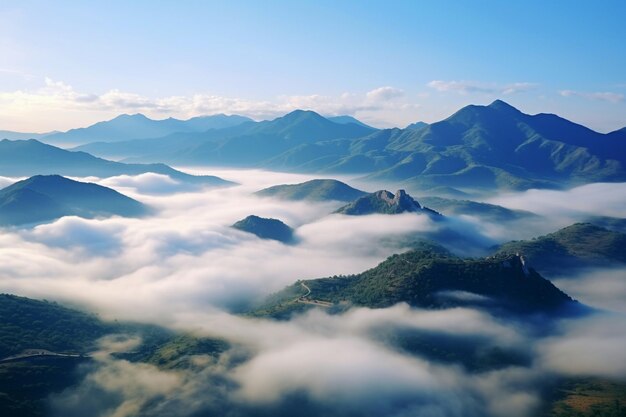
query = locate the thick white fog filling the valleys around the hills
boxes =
[0,170,626,417]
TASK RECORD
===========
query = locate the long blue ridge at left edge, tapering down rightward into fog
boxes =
[0,139,234,187]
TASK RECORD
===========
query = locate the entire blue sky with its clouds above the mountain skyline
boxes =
[0,1,626,131]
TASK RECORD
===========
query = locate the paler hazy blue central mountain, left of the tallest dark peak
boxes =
[77,110,376,168]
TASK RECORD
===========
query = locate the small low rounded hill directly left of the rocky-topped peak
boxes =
[255,180,366,201]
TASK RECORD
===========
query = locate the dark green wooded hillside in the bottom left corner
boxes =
[0,294,227,417]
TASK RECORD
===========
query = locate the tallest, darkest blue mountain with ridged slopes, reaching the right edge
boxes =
[371,100,626,189]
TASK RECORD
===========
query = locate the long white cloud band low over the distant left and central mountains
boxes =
[0,78,417,131]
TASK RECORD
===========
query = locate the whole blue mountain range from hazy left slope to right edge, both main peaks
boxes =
[59,100,626,190]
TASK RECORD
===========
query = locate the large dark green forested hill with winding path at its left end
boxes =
[257,245,577,317]
